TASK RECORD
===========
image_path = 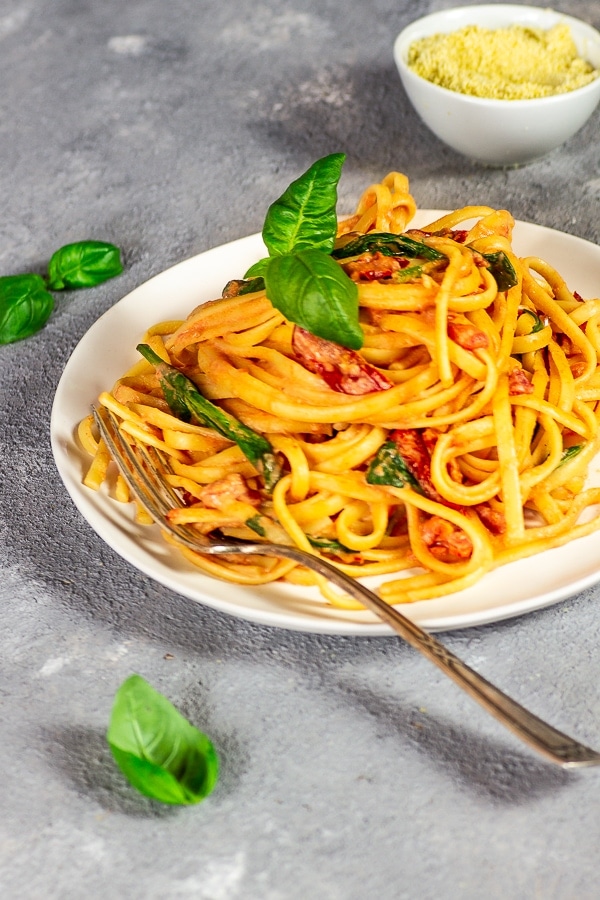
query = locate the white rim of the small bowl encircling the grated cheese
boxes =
[394,3,600,109]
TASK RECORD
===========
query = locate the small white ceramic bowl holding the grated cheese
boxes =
[394,4,600,166]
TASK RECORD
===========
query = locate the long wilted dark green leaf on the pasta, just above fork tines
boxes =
[137,344,281,491]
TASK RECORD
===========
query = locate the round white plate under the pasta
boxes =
[51,210,600,635]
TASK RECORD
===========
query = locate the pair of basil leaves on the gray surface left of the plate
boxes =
[0,241,123,344]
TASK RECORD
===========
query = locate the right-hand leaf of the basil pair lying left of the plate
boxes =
[48,241,123,291]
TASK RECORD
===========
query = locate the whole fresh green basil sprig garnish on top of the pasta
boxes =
[245,153,364,350]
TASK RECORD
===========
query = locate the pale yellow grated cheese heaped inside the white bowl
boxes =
[408,25,600,100]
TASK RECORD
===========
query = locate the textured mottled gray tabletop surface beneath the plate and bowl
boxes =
[0,0,600,900]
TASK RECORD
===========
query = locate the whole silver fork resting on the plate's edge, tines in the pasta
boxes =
[93,407,600,769]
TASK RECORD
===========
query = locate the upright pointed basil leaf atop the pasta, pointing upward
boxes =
[264,153,346,256]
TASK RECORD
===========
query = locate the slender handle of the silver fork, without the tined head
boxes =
[226,543,600,768]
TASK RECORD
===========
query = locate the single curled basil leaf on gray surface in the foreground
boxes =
[106,675,219,805]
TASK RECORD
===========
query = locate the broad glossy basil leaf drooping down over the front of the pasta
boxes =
[265,249,364,350]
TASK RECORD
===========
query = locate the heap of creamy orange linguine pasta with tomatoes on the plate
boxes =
[79,173,600,607]
